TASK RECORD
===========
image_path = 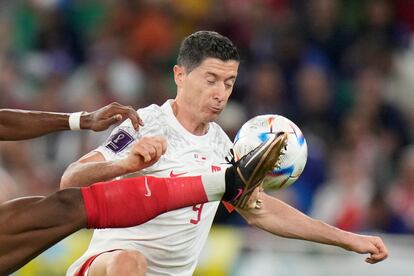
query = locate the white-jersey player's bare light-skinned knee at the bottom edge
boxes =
[106,250,147,276]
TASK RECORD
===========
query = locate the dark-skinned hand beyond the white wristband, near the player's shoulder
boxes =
[80,102,144,131]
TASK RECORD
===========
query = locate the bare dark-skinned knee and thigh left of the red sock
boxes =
[0,189,87,275]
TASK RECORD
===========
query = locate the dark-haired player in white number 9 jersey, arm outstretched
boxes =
[62,31,387,276]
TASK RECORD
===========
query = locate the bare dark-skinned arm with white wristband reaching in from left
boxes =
[0,103,142,140]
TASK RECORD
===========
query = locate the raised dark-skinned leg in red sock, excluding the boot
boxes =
[0,174,207,275]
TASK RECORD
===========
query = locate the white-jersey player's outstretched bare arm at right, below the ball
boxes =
[238,193,388,263]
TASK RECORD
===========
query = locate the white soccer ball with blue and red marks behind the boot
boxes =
[233,114,308,189]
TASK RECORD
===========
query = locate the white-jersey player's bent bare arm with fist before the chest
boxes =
[60,136,167,188]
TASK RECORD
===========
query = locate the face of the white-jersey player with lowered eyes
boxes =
[174,58,239,123]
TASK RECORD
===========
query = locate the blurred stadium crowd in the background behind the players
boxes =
[0,0,414,233]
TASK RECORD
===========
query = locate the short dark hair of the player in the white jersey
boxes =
[177,31,240,73]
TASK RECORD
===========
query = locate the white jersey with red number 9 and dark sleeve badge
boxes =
[67,100,232,276]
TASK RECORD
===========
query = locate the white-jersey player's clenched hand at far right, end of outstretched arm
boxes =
[344,234,388,264]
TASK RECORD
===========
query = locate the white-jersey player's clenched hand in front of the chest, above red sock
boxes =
[119,136,167,173]
